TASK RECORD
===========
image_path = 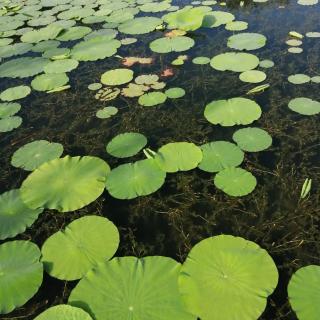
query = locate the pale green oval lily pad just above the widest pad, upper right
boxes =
[227,33,267,51]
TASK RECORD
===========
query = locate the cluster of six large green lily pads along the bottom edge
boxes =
[0,215,320,320]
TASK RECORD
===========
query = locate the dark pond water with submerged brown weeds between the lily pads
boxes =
[0,1,320,320]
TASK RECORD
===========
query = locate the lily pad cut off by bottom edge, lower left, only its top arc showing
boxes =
[34,304,92,320]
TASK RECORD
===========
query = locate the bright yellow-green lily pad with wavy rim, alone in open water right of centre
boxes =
[204,98,262,127]
